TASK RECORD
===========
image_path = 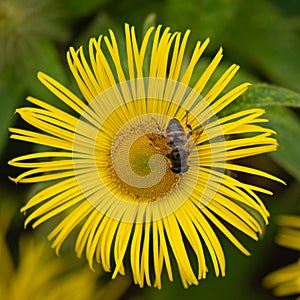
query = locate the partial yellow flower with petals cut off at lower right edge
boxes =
[263,216,300,299]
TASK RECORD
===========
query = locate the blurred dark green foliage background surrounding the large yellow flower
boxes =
[0,0,300,300]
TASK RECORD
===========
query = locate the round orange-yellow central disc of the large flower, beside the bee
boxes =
[108,124,180,202]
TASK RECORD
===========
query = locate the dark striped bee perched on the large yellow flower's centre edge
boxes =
[148,111,203,174]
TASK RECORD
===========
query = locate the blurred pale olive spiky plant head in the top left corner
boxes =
[0,0,67,74]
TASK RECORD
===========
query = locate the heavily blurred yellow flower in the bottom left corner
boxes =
[0,199,130,300]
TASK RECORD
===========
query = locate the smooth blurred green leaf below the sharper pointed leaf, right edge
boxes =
[265,106,300,181]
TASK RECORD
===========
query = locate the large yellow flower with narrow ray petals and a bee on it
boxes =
[10,24,280,288]
